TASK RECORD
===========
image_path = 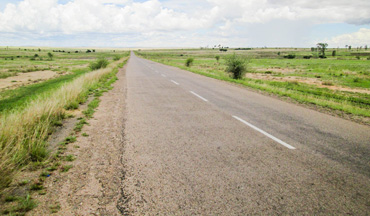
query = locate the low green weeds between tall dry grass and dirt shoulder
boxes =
[0,58,127,215]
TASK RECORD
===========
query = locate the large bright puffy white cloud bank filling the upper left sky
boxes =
[0,0,217,35]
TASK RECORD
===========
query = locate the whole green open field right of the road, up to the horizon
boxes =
[137,48,370,124]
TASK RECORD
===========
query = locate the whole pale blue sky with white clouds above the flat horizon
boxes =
[0,0,370,48]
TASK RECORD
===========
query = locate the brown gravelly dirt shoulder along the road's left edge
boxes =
[28,64,126,215]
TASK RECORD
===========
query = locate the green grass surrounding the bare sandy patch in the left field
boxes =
[0,47,129,115]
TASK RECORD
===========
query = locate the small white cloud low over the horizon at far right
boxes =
[328,28,370,47]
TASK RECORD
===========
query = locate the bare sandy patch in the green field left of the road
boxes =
[0,70,57,89]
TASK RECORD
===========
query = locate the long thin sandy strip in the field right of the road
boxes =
[245,73,370,94]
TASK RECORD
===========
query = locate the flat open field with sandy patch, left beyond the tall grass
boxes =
[0,48,128,112]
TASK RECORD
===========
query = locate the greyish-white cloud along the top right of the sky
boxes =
[208,0,370,24]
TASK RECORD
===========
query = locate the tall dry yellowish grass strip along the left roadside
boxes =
[0,59,124,189]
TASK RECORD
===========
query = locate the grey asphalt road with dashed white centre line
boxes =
[123,52,370,215]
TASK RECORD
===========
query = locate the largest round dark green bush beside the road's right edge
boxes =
[226,53,247,79]
